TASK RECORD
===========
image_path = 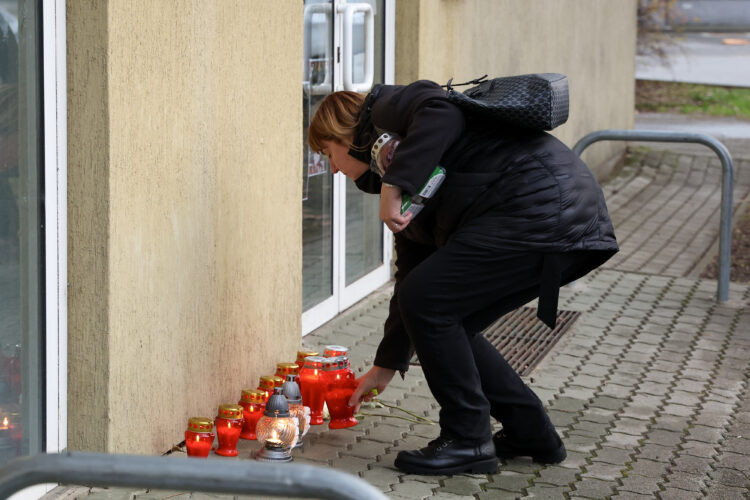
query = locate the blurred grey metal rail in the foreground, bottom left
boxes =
[0,452,386,500]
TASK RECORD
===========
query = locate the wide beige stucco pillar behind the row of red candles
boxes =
[67,0,302,453]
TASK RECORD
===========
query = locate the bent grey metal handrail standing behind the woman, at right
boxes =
[573,130,734,302]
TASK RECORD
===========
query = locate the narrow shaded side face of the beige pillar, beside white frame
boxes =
[67,1,109,451]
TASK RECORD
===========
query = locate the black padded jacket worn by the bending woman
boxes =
[350,80,618,371]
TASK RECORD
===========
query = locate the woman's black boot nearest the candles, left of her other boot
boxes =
[394,437,498,475]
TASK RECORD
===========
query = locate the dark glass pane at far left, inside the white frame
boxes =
[0,0,42,464]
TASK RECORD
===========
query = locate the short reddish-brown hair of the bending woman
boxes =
[307,90,365,151]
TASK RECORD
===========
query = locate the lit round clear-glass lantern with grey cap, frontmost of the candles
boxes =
[255,388,299,462]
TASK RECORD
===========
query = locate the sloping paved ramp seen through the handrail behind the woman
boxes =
[604,143,750,277]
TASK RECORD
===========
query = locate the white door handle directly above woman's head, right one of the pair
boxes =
[341,3,375,92]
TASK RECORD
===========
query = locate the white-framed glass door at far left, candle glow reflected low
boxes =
[0,0,67,500]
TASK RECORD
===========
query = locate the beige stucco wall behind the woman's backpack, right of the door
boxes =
[396,0,636,176]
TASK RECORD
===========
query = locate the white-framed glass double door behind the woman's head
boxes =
[302,0,393,333]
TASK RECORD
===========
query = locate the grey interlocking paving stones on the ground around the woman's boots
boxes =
[46,143,750,500]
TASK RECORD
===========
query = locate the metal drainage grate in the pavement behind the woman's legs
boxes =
[412,307,581,376]
